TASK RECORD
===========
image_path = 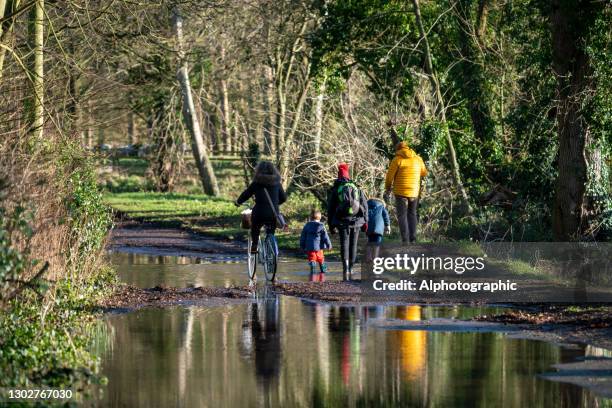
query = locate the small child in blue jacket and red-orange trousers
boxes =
[300,210,331,281]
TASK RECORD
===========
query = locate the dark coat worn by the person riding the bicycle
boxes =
[236,174,287,223]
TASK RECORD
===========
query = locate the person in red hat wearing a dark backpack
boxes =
[327,163,368,281]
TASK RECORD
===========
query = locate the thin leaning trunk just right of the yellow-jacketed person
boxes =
[412,0,472,214]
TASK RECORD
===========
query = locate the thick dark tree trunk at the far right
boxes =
[550,0,603,241]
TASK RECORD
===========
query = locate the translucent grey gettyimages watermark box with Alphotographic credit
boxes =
[361,243,612,303]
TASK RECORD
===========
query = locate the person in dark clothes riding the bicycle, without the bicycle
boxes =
[235,161,287,253]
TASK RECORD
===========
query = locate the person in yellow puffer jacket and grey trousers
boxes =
[385,142,427,242]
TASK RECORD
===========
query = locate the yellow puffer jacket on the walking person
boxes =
[385,147,427,197]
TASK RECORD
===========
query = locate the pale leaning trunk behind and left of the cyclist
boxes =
[172,8,219,196]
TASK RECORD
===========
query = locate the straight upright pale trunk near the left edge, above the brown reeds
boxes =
[30,0,45,140]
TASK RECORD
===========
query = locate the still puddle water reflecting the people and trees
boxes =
[95,255,610,408]
